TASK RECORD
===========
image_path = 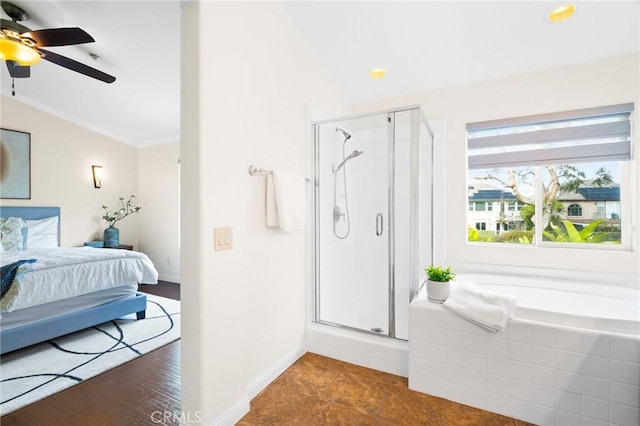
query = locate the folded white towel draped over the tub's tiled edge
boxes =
[442,282,517,331]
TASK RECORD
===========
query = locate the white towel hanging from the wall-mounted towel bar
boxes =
[266,170,306,232]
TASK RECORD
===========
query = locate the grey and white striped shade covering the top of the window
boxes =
[467,103,634,169]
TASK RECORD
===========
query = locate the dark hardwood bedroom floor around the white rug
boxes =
[0,281,181,426]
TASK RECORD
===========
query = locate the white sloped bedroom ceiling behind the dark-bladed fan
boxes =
[0,0,180,146]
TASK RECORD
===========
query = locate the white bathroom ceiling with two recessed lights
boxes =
[285,0,640,102]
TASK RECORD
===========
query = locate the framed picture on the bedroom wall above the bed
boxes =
[0,129,31,199]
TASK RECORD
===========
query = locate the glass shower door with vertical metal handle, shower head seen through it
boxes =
[314,114,394,335]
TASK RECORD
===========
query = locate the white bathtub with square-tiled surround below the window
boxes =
[409,273,640,425]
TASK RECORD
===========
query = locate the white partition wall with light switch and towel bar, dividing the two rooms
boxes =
[180,2,348,424]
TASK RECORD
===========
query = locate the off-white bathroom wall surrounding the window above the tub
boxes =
[354,53,640,276]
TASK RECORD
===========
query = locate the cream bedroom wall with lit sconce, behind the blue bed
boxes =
[0,96,140,246]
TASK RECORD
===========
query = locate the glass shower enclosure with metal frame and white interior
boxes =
[313,106,433,339]
